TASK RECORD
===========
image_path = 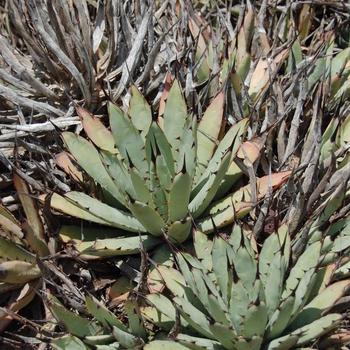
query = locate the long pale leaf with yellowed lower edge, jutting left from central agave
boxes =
[39,191,146,232]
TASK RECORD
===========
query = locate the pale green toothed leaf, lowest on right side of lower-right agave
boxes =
[296,314,343,346]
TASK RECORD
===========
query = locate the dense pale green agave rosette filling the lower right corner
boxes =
[142,187,350,350]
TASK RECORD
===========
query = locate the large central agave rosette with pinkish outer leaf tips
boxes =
[42,80,290,254]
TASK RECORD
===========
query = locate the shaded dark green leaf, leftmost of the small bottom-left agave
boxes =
[49,301,101,337]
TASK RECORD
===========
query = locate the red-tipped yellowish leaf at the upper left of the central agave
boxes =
[76,106,118,154]
